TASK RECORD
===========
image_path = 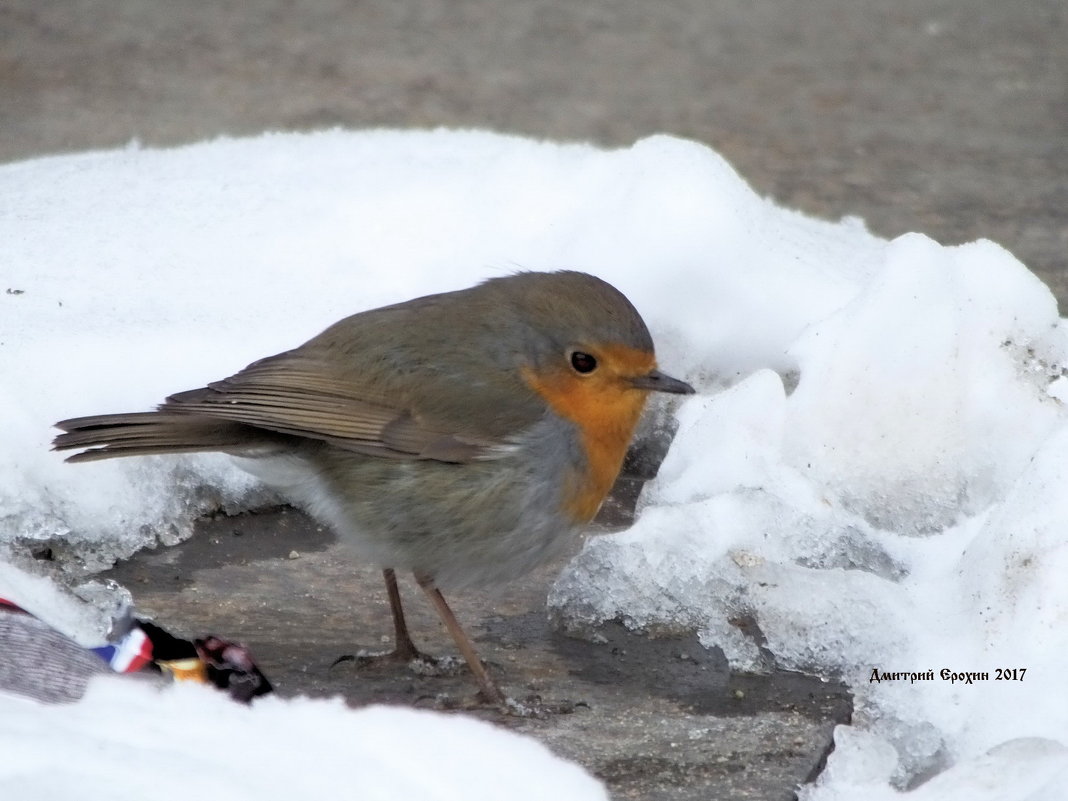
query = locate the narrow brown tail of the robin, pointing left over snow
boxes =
[52,411,280,461]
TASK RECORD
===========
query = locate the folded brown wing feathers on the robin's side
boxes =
[159,350,506,462]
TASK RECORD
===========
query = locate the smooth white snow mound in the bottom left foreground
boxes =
[0,676,608,801]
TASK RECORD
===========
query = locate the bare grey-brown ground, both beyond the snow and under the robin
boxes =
[0,0,1068,799]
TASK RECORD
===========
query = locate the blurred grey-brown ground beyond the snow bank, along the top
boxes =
[0,0,1068,299]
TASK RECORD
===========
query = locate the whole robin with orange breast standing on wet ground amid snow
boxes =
[53,271,693,705]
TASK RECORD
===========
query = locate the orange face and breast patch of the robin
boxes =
[523,346,656,522]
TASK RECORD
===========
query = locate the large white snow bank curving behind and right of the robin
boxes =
[0,131,1068,801]
